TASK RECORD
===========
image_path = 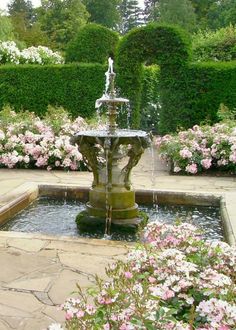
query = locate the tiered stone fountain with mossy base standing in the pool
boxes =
[72,58,151,235]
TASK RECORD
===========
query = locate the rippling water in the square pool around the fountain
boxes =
[0,197,223,241]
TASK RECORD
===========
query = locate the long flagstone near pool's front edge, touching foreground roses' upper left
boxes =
[59,252,113,277]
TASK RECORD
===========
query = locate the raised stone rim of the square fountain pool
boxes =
[0,183,236,246]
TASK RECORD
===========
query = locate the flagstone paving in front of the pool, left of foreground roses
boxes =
[0,233,127,330]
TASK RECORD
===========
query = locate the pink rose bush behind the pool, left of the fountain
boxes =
[0,107,91,170]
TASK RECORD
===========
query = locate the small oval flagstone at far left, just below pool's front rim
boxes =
[7,238,46,252]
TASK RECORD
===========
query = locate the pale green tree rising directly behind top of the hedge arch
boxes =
[159,0,196,32]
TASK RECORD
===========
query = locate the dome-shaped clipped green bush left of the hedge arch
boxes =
[66,24,119,64]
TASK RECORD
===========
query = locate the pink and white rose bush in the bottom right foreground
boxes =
[52,222,236,330]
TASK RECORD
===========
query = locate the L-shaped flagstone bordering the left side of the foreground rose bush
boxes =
[48,270,92,305]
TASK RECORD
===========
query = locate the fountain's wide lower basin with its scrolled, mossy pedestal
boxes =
[73,130,150,224]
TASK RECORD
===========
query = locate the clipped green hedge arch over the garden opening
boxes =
[117,23,190,128]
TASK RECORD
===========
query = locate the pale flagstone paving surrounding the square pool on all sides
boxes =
[0,151,236,330]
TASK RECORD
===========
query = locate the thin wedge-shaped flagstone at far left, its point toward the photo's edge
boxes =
[5,277,52,291]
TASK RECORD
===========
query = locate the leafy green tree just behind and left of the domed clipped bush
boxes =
[38,0,89,50]
